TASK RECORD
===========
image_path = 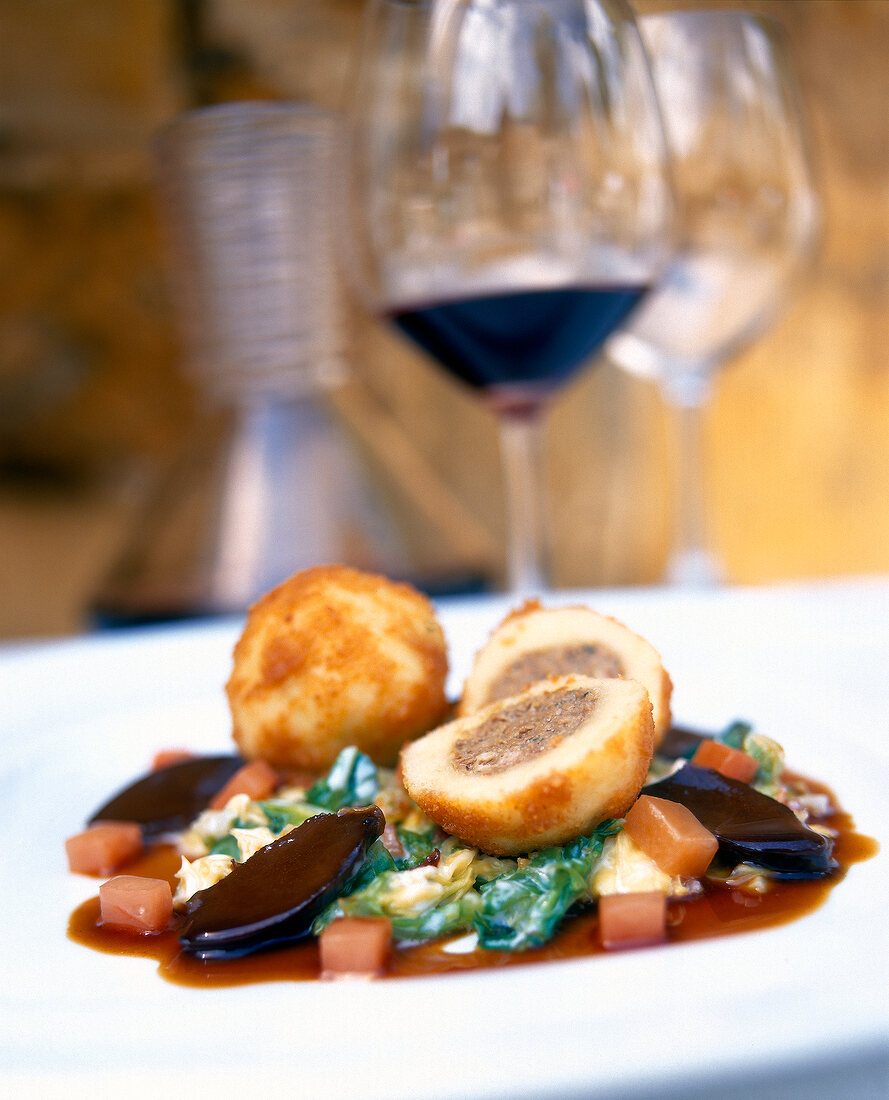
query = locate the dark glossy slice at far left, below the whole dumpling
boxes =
[89,755,244,839]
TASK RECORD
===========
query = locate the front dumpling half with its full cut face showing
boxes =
[402,677,654,856]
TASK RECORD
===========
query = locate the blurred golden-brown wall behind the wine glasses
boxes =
[0,0,889,638]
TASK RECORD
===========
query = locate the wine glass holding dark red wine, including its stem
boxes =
[345,0,672,593]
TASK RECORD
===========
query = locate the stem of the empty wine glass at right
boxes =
[663,377,722,586]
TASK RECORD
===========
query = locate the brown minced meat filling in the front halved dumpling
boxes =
[451,688,595,776]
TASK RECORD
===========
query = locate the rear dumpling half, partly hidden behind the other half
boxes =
[458,601,672,745]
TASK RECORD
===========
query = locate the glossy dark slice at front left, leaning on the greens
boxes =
[179,806,385,958]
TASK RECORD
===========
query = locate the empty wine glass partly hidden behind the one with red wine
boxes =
[606,10,819,585]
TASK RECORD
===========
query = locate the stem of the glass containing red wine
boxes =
[498,411,546,596]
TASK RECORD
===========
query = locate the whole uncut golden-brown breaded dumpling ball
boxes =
[226,565,448,769]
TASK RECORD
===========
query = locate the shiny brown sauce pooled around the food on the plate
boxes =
[68,781,878,988]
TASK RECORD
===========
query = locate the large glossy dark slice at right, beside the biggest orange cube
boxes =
[643,763,836,878]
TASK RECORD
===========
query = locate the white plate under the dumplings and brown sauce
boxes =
[0,581,889,1100]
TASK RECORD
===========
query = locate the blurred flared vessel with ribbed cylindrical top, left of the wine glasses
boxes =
[90,101,406,623]
